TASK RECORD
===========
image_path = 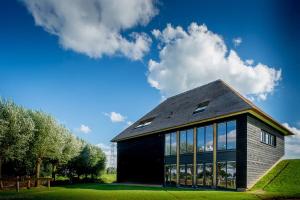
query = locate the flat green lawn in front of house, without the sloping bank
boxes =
[0,184,257,200]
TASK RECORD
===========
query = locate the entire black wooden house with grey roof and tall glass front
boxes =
[112,80,293,190]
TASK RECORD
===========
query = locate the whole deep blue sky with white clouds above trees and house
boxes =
[0,0,300,157]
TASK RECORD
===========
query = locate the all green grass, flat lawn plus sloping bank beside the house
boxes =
[0,160,300,200]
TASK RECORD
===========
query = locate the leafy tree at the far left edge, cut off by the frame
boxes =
[0,99,34,178]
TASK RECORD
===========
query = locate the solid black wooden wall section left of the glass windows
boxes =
[117,134,164,184]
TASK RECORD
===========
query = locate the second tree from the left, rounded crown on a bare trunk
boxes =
[30,111,64,185]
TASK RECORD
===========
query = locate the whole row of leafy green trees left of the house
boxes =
[0,99,106,178]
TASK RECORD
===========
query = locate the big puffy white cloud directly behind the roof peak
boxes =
[147,23,281,99]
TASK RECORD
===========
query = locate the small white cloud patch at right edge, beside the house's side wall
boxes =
[283,123,300,158]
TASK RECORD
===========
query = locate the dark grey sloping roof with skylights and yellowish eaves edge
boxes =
[112,80,292,142]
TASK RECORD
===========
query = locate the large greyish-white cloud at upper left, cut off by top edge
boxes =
[23,0,158,60]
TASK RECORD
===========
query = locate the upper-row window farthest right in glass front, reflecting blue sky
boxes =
[217,120,236,150]
